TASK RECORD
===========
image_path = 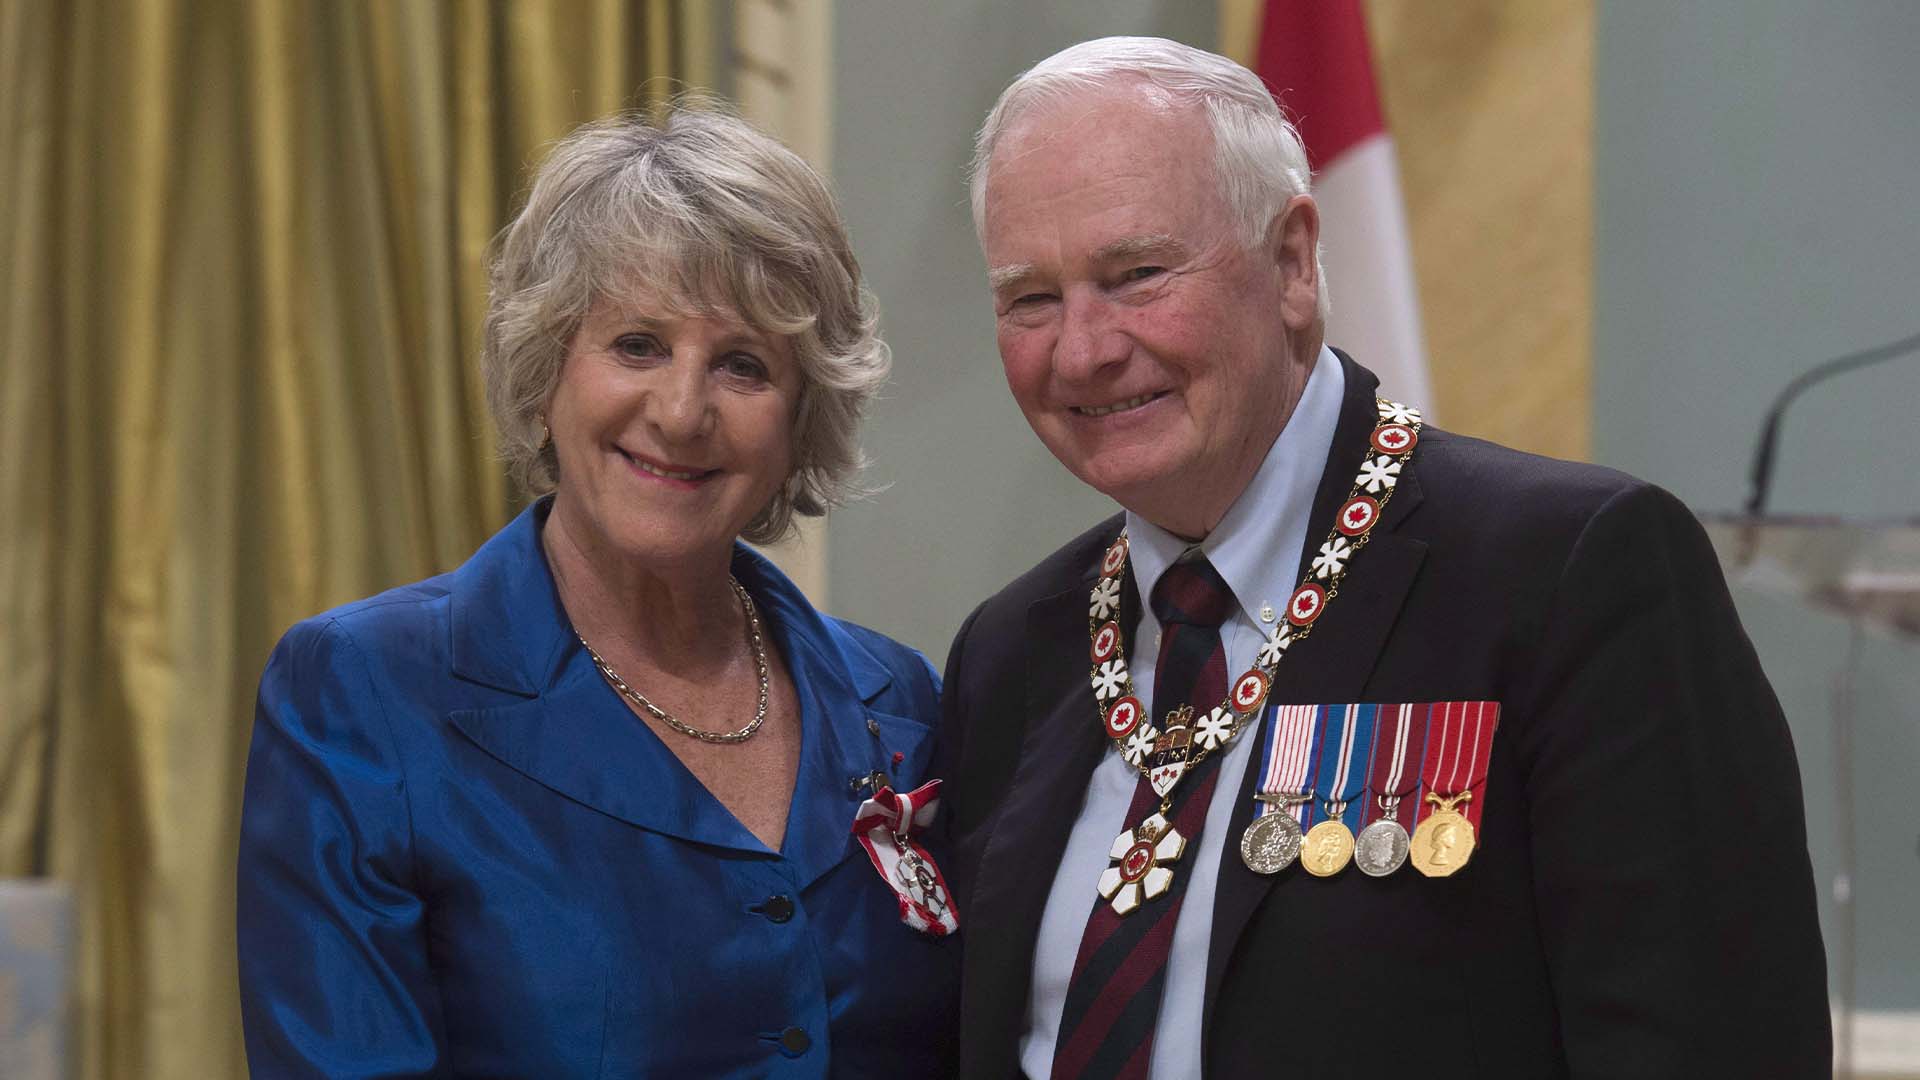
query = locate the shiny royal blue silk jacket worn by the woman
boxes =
[238,505,958,1078]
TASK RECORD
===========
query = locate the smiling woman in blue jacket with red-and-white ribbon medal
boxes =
[238,110,956,1078]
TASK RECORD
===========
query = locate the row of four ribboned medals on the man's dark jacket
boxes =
[1240,701,1500,878]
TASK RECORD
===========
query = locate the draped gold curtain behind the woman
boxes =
[0,0,710,1080]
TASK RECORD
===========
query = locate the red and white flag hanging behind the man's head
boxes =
[1254,0,1432,411]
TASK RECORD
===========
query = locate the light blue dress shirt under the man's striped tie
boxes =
[1020,348,1346,1080]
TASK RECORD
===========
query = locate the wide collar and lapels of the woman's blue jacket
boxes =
[447,500,902,884]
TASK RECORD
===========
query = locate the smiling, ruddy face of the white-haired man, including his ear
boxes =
[983,85,1319,536]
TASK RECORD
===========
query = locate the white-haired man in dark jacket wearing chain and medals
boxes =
[941,38,1830,1080]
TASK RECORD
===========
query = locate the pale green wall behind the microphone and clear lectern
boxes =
[1594,0,1920,1014]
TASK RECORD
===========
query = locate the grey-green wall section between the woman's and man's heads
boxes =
[828,0,1217,653]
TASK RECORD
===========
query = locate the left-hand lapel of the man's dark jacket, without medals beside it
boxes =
[962,557,1139,1076]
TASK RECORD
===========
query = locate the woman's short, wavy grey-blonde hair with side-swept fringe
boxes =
[480,98,891,544]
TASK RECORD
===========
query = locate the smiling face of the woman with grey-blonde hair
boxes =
[547,286,801,569]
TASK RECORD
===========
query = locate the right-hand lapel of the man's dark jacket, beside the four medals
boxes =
[1202,354,1427,1037]
